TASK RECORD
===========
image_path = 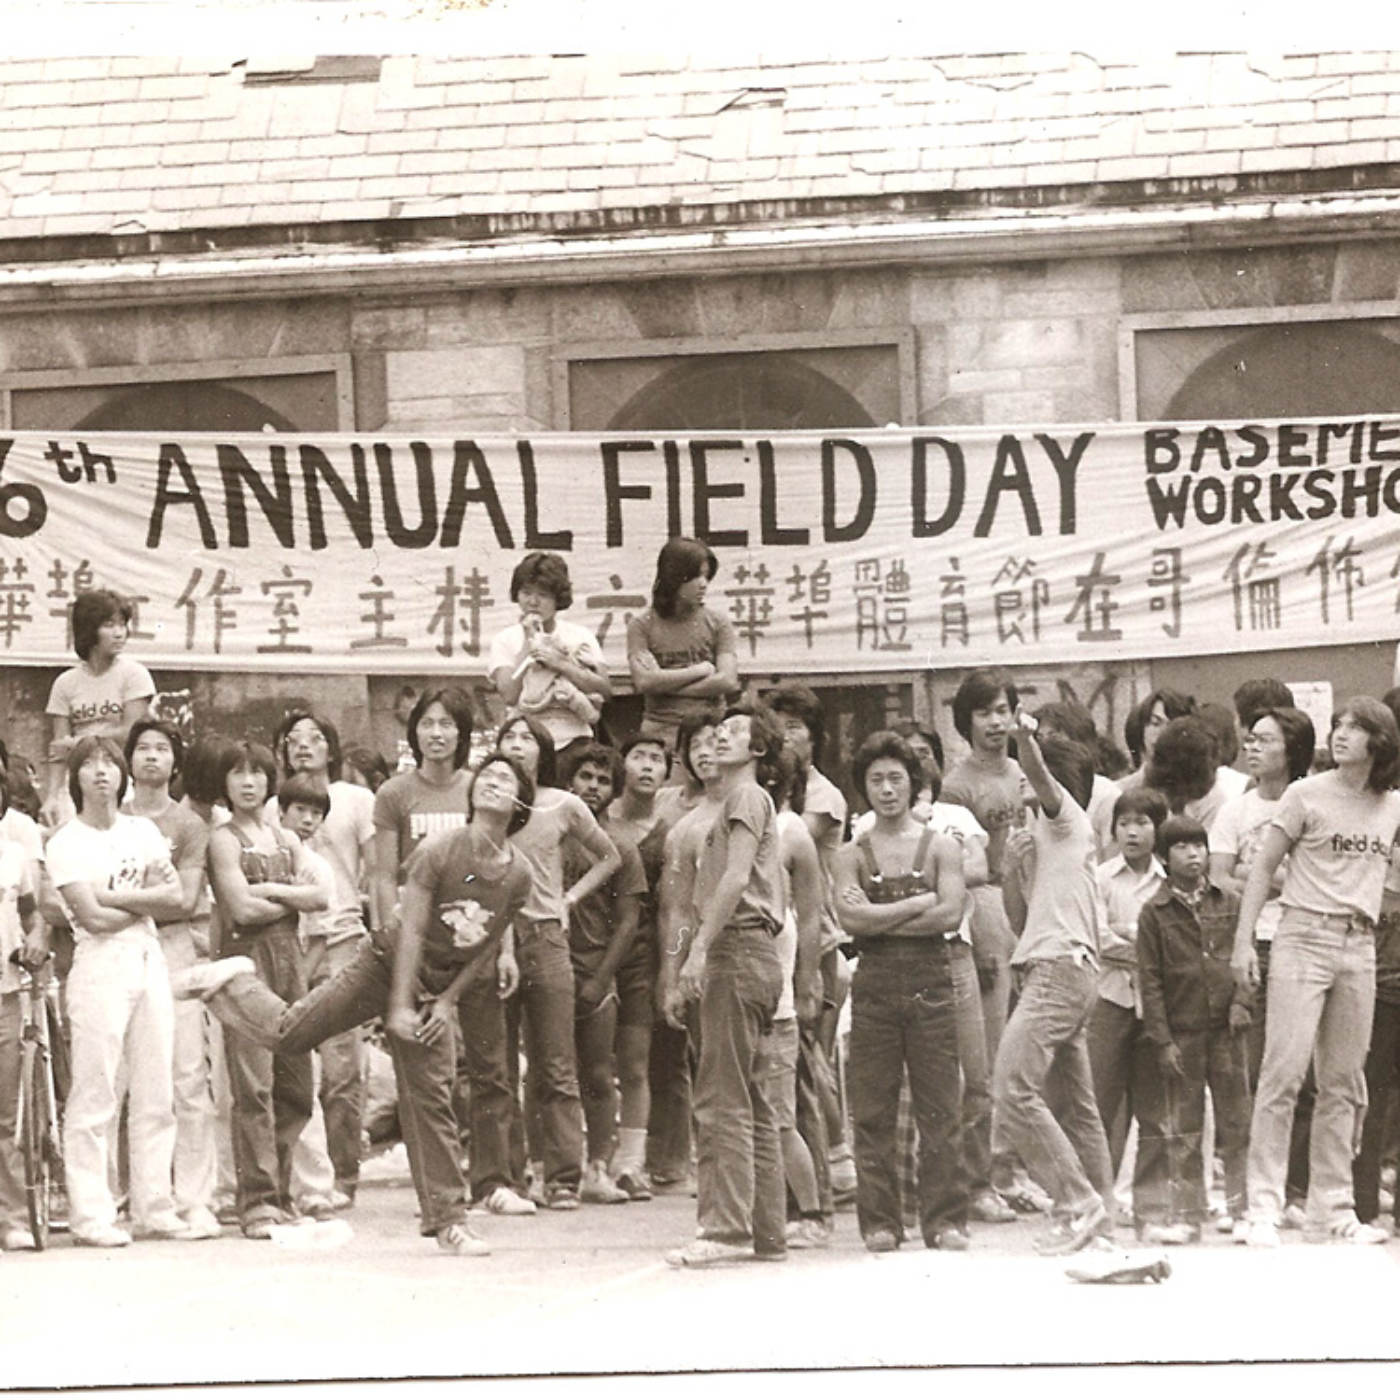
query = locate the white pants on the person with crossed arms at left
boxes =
[63,934,175,1235]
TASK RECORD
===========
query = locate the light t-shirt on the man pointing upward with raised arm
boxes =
[1011,788,1099,965]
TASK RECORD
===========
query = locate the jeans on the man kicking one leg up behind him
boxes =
[207,939,466,1235]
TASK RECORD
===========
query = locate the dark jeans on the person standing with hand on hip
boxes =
[505,918,584,1186]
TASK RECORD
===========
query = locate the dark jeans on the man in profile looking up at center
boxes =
[694,928,787,1257]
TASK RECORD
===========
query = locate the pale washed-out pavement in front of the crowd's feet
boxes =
[0,1186,1400,1387]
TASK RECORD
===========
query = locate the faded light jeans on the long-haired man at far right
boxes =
[1249,907,1376,1225]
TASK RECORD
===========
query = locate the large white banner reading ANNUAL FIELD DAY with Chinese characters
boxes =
[0,419,1400,673]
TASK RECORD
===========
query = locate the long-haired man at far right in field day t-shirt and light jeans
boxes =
[1231,696,1400,1247]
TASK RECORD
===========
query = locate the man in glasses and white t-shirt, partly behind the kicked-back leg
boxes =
[266,710,375,1205]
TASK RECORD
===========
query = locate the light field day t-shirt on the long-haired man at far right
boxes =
[1273,771,1400,918]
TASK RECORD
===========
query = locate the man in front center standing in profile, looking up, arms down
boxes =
[666,706,787,1267]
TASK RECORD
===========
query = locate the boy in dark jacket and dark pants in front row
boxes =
[1133,816,1252,1245]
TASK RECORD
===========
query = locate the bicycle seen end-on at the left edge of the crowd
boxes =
[10,949,63,1249]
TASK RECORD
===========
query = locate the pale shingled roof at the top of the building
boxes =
[0,52,1400,241]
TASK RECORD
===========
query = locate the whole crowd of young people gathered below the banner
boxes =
[0,538,1400,1268]
